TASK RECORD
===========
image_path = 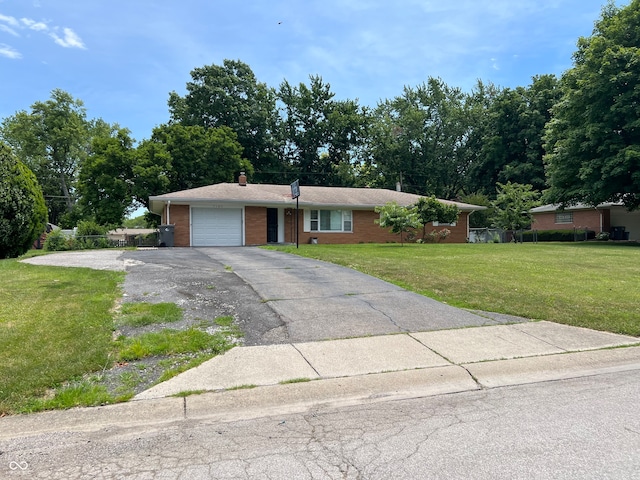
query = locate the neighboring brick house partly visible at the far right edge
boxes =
[531,203,640,241]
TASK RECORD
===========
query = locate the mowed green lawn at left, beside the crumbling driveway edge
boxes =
[0,260,124,415]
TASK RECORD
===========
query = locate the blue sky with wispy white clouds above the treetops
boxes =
[0,0,628,141]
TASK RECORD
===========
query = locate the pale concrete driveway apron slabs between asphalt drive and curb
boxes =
[135,321,640,400]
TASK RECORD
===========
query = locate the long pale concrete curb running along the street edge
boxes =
[0,346,640,440]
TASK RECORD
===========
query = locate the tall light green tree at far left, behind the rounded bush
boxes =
[0,89,89,223]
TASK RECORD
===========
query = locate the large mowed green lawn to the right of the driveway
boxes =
[270,242,640,336]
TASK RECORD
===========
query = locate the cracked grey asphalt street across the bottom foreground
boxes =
[0,371,640,480]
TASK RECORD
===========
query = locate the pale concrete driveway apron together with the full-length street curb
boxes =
[0,321,640,439]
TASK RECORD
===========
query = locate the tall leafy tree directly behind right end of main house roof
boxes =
[367,78,472,199]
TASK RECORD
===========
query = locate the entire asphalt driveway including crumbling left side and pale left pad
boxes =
[27,247,525,345]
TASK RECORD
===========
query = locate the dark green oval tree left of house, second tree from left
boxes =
[78,124,135,226]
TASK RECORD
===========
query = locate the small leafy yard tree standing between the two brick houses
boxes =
[493,182,540,239]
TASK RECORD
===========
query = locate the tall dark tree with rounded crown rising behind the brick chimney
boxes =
[169,60,284,183]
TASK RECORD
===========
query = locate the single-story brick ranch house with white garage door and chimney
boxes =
[149,175,485,247]
